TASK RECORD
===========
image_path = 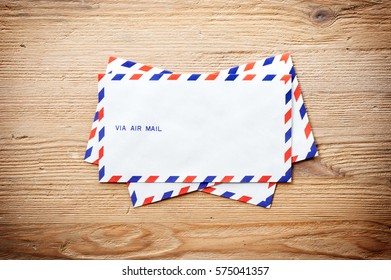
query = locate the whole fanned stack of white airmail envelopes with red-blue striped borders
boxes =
[84,53,318,208]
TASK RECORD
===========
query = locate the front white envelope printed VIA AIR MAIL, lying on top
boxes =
[99,73,292,183]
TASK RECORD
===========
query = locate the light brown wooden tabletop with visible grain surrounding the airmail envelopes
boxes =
[0,0,391,259]
